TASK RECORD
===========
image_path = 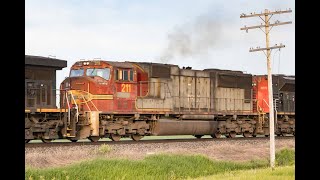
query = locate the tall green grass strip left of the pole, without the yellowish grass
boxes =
[25,155,268,180]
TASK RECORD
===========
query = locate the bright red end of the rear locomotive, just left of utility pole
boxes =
[252,75,269,113]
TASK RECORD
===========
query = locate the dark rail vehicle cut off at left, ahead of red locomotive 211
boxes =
[25,55,68,143]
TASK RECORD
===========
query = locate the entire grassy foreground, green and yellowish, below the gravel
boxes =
[25,149,294,180]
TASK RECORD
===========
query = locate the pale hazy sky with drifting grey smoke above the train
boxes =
[25,0,295,87]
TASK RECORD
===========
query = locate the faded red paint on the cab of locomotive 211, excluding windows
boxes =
[62,61,148,113]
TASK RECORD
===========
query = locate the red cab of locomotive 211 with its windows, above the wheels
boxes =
[61,61,137,112]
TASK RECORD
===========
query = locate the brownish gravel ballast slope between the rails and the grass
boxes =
[25,138,295,168]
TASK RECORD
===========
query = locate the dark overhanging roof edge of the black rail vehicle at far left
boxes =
[25,55,67,70]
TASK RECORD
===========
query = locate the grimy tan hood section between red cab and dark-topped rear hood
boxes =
[137,63,210,113]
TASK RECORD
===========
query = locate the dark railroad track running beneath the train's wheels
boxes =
[25,136,295,148]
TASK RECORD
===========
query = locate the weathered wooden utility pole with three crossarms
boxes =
[240,9,292,170]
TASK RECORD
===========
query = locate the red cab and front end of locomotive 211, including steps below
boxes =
[61,61,149,141]
